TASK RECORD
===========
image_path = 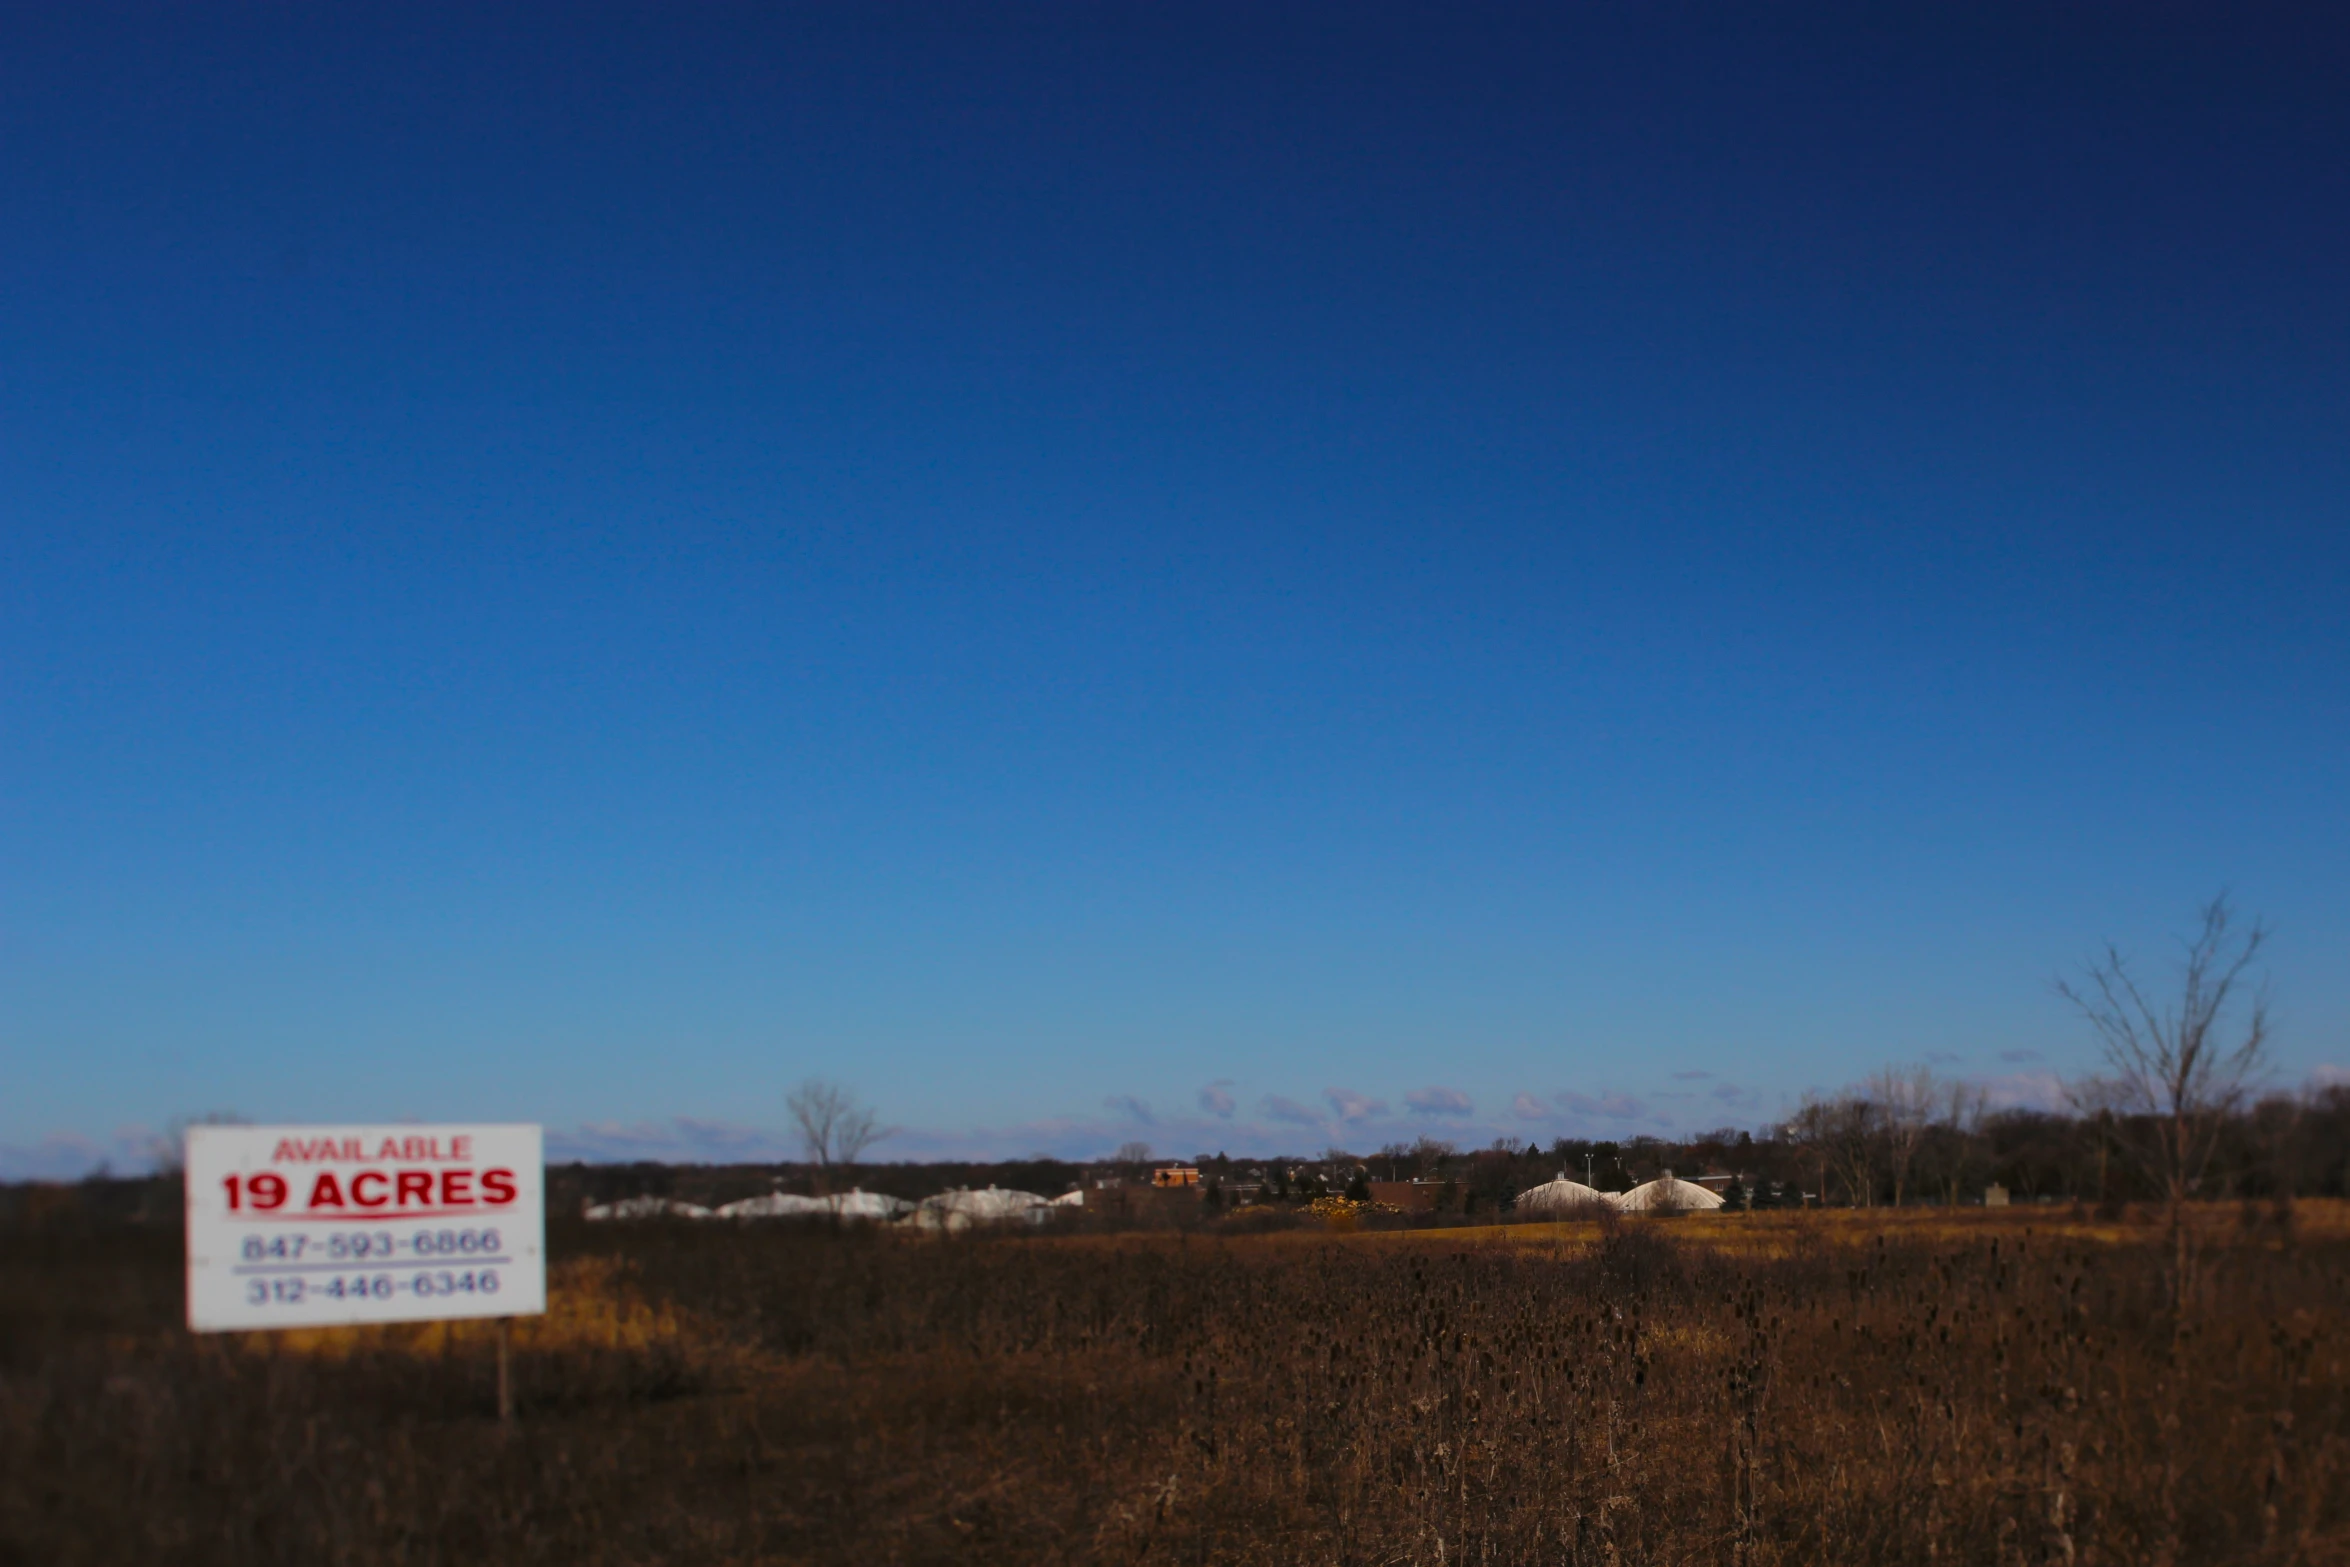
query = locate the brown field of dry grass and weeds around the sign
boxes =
[0,1203,2350,1565]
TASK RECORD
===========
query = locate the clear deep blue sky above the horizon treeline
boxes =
[0,5,2350,1172]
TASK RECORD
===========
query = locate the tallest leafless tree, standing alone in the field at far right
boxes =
[2056,893,2268,1316]
